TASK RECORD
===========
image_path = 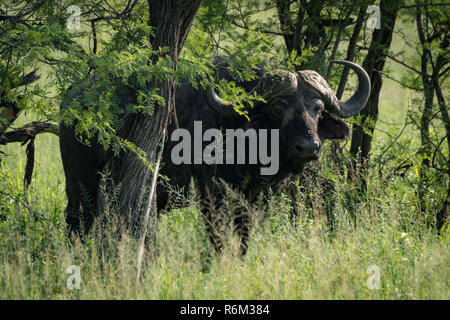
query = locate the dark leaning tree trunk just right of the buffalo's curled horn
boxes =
[350,0,400,190]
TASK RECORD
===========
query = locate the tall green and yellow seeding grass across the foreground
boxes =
[0,143,450,299]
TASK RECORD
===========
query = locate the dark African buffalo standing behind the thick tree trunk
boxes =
[60,59,370,250]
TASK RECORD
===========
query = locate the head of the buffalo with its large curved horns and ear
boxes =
[205,60,371,171]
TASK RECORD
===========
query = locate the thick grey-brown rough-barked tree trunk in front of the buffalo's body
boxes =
[103,0,202,231]
